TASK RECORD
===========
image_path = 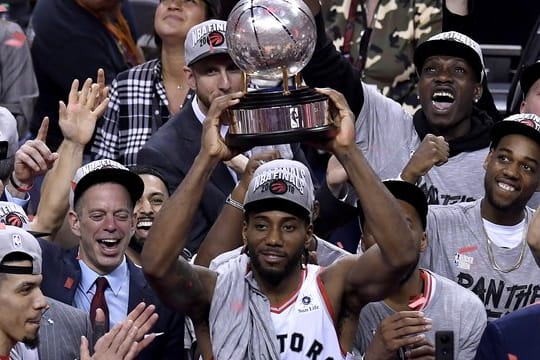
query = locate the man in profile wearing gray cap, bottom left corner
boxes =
[0,224,48,360]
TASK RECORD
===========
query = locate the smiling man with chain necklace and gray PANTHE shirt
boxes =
[421,114,540,320]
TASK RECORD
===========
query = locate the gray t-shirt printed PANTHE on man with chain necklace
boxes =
[420,200,540,320]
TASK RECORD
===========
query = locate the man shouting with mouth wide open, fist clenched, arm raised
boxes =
[302,0,493,207]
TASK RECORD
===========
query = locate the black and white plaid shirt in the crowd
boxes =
[91,59,190,166]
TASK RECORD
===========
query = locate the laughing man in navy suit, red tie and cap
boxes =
[40,160,184,359]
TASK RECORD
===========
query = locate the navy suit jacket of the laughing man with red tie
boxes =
[39,239,184,360]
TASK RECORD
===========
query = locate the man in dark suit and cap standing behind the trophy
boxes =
[137,20,307,253]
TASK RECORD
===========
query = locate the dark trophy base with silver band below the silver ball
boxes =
[225,87,336,147]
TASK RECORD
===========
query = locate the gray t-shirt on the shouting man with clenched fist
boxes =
[356,85,489,205]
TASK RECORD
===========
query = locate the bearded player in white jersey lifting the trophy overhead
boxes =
[142,89,418,359]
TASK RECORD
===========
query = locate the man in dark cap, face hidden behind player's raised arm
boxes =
[355,180,487,360]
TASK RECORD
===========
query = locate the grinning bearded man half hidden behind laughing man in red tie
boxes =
[126,166,169,265]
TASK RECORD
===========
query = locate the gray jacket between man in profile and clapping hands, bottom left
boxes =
[10,298,92,360]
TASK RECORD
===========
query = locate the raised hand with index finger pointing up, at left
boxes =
[12,117,58,188]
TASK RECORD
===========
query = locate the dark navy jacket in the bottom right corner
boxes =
[476,304,540,360]
